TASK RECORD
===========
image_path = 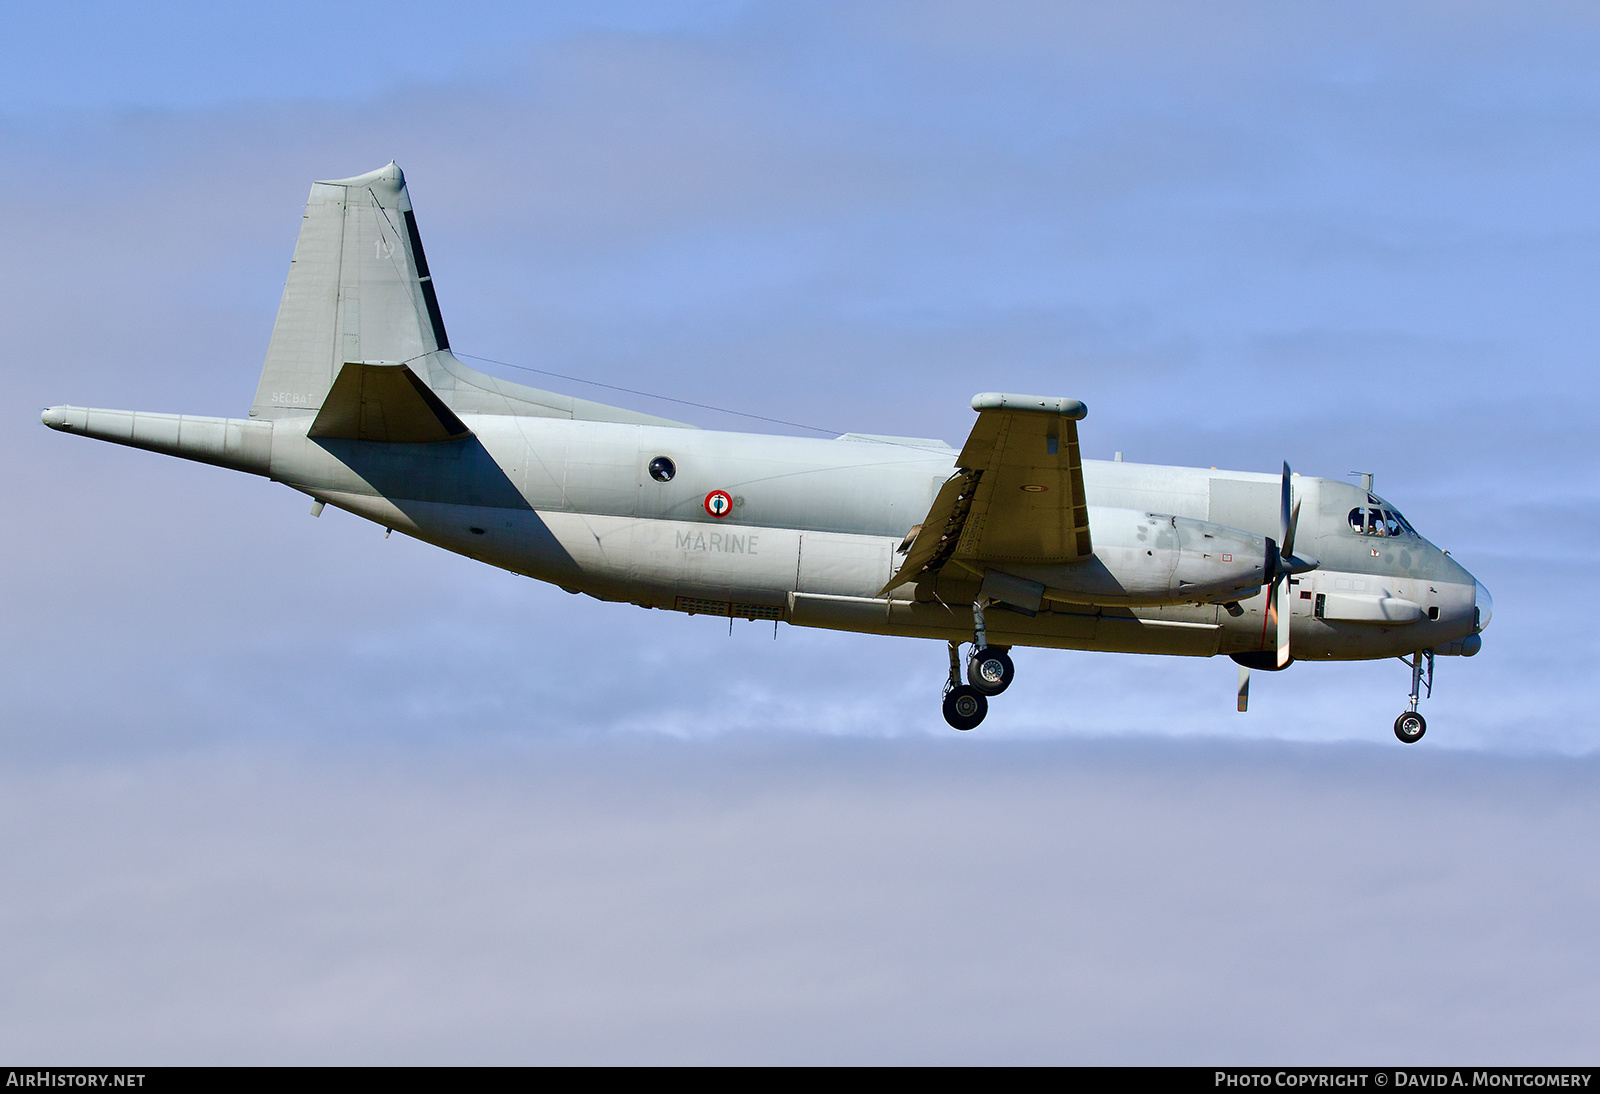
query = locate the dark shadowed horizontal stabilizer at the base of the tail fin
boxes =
[307,361,472,445]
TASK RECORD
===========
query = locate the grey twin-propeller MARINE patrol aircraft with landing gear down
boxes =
[43,163,1493,744]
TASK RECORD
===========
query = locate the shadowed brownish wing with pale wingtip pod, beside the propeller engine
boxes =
[880,392,1094,595]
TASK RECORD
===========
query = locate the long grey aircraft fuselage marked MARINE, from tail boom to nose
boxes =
[46,408,1488,661]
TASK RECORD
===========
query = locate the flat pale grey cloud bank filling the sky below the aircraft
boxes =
[0,736,1600,1064]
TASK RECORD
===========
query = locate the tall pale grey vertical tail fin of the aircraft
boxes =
[250,163,450,419]
